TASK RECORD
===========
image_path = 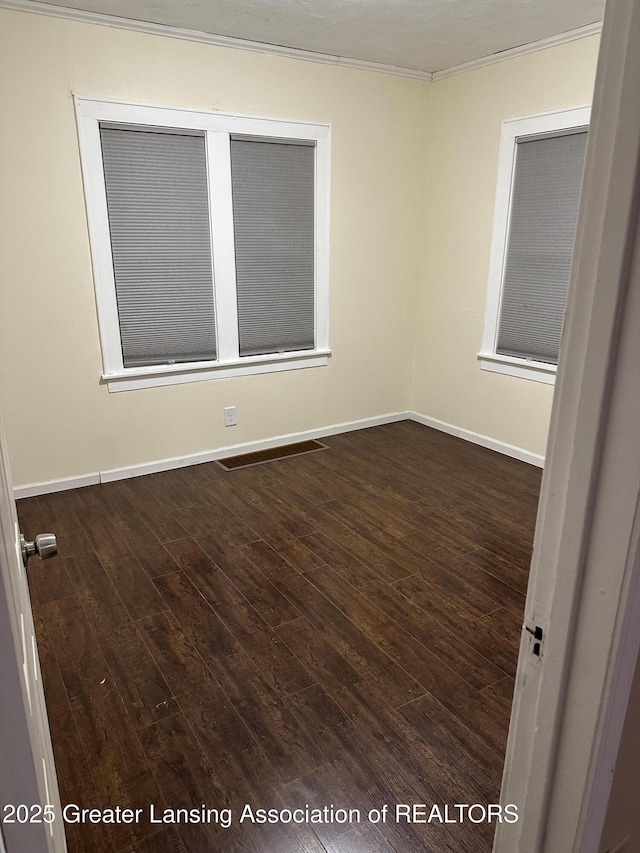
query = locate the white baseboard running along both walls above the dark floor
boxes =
[13,412,544,499]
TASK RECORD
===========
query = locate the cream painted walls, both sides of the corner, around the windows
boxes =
[0,11,598,485]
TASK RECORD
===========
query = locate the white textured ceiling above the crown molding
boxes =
[17,0,604,73]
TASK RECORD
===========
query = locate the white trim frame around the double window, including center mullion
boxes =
[74,95,331,391]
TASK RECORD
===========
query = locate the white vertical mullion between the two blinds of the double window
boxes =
[207,131,239,362]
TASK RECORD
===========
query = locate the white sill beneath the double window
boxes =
[101,350,331,392]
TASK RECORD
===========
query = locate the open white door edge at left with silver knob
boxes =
[0,410,67,853]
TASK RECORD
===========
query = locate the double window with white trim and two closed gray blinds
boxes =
[76,99,330,390]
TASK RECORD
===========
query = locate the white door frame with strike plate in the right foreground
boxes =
[494,0,640,853]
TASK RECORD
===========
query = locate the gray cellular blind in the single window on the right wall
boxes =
[496,130,587,364]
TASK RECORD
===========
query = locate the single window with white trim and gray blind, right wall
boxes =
[479,107,589,383]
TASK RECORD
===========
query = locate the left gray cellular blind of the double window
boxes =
[100,126,216,367]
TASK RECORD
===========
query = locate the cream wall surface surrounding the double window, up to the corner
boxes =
[0,11,428,484]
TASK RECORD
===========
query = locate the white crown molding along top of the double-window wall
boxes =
[0,0,432,82]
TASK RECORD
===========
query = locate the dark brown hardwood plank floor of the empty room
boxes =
[18,421,540,853]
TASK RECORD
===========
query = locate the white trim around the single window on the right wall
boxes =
[477,106,591,385]
